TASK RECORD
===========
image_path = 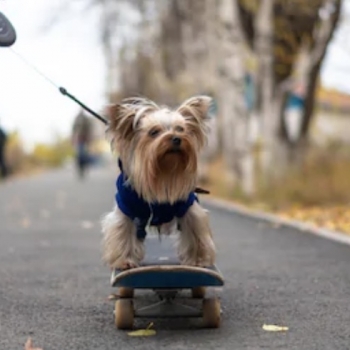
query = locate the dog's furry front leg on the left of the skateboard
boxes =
[102,207,144,269]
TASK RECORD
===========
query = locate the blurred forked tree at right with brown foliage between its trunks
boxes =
[238,0,341,179]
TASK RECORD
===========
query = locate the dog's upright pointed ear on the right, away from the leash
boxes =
[177,95,212,123]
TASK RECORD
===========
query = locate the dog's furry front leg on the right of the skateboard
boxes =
[178,202,216,266]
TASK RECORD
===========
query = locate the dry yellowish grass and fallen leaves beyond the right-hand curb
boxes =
[203,145,350,234]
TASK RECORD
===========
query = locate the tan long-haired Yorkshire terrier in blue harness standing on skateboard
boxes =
[102,96,215,269]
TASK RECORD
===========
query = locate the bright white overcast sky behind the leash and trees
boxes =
[0,0,350,147]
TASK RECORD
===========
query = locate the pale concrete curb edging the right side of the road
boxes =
[201,197,350,245]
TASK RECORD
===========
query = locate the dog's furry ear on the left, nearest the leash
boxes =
[106,103,136,140]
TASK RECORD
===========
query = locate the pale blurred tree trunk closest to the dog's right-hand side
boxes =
[219,0,255,195]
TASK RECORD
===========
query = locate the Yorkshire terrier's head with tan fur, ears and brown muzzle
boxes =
[107,96,211,204]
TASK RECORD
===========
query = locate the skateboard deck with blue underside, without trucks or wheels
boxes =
[111,237,224,289]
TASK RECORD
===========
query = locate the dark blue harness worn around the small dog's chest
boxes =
[115,159,198,240]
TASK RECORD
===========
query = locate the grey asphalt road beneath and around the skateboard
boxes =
[0,170,350,350]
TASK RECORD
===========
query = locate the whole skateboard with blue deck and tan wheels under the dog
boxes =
[111,237,224,329]
